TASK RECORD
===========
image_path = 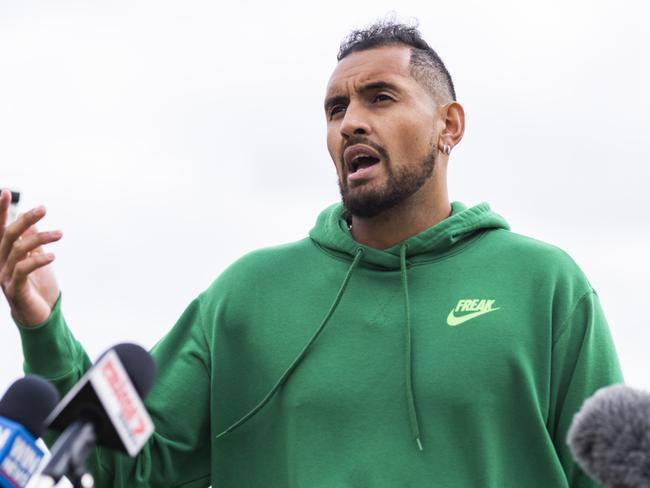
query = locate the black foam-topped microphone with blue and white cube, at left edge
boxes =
[0,375,59,488]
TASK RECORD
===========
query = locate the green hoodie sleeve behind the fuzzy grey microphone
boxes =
[549,290,623,488]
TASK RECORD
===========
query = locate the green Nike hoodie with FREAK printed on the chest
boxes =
[20,203,621,488]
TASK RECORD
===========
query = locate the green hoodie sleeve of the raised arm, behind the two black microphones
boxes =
[19,298,210,487]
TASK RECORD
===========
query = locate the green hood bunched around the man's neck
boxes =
[309,202,510,270]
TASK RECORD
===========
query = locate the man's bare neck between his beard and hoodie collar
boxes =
[350,195,451,249]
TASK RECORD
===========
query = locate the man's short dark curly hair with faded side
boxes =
[336,19,456,103]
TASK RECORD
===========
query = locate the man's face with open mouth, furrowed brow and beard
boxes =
[325,46,437,217]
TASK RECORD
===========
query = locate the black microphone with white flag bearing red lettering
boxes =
[41,343,156,486]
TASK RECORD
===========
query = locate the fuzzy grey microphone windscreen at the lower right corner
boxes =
[567,385,650,488]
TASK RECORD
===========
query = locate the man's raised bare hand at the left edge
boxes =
[0,190,62,326]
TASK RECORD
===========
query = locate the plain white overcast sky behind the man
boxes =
[0,0,650,393]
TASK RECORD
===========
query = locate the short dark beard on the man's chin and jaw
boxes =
[339,146,437,218]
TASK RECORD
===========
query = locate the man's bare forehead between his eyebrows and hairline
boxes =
[327,46,411,95]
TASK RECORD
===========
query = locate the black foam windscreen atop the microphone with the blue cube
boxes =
[0,375,59,438]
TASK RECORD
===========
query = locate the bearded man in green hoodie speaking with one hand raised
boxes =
[0,23,621,488]
